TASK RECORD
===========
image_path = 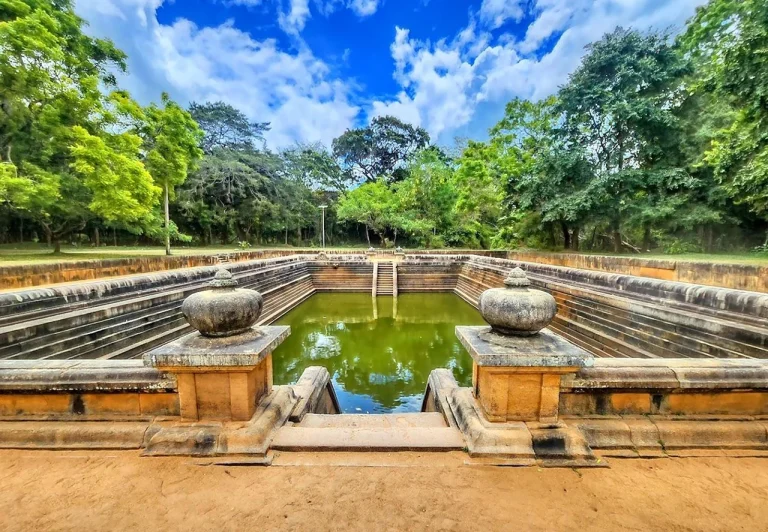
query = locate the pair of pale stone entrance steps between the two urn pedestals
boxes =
[271,412,465,452]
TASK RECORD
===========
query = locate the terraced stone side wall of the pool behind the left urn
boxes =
[0,256,314,360]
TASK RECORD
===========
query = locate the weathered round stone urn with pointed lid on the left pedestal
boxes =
[181,268,264,338]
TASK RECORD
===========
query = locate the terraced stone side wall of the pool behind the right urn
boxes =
[456,257,768,359]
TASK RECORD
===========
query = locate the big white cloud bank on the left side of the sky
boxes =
[76,0,359,148]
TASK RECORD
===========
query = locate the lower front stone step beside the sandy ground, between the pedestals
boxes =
[270,424,466,452]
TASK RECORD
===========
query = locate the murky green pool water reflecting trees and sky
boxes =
[272,293,485,414]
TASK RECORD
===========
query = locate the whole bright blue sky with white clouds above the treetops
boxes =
[75,0,705,149]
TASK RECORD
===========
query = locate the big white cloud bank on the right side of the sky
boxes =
[369,0,707,142]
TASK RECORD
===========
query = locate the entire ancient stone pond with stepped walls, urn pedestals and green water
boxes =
[0,250,768,466]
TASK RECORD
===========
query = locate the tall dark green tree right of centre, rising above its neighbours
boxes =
[559,28,690,251]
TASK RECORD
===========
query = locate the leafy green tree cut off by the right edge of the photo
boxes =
[680,0,768,245]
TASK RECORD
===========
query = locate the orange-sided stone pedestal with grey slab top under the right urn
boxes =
[456,326,593,423]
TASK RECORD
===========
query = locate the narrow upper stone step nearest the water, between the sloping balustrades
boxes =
[295,412,448,429]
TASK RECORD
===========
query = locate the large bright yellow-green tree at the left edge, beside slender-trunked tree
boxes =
[0,0,157,251]
